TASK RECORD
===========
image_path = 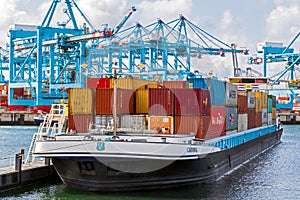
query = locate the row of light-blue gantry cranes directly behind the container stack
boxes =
[87,15,248,80]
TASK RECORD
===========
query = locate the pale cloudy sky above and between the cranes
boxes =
[0,0,300,77]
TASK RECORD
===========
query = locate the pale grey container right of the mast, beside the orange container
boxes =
[121,115,147,130]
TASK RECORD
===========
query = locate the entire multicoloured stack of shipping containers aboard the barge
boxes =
[68,78,276,140]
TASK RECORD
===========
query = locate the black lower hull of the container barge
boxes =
[52,129,282,192]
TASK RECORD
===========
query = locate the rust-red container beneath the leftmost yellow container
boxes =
[68,114,93,133]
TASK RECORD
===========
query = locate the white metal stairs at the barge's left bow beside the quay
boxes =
[25,104,67,164]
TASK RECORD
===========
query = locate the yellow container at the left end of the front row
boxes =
[68,88,95,115]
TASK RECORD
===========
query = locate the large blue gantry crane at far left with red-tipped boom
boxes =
[9,0,136,106]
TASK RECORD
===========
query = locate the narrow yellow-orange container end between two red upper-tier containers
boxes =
[135,89,149,114]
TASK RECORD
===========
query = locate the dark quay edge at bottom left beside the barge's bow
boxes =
[0,151,59,193]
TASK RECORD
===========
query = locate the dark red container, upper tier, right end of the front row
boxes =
[174,88,210,115]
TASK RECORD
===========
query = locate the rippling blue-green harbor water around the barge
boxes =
[0,125,300,200]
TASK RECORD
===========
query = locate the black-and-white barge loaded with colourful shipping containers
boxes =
[33,76,283,192]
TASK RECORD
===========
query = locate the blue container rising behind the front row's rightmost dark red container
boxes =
[189,78,225,106]
